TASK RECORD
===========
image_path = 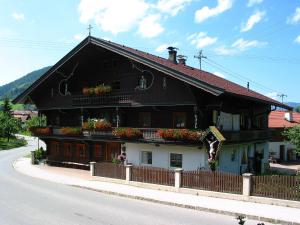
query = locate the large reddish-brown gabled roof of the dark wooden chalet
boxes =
[13,36,291,109]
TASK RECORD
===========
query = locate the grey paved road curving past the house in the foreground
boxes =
[0,136,268,225]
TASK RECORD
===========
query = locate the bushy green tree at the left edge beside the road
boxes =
[0,112,21,142]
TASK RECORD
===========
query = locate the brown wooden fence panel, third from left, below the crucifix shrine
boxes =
[182,170,243,194]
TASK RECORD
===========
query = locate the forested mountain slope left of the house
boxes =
[0,66,51,100]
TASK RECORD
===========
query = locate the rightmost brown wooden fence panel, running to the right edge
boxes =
[251,175,300,201]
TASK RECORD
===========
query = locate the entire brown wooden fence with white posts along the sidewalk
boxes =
[91,162,300,201]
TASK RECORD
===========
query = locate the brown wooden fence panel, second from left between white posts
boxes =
[131,166,175,186]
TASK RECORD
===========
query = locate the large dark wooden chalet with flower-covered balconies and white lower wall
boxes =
[14,36,290,174]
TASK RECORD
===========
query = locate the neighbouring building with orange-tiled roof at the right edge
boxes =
[269,110,300,161]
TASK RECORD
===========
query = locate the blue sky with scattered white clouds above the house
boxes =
[0,0,300,102]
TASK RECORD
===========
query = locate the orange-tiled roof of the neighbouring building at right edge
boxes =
[269,110,300,128]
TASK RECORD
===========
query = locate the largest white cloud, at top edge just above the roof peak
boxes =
[78,0,150,34]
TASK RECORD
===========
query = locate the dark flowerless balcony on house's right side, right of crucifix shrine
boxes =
[221,130,271,142]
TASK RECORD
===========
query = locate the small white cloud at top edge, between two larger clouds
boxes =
[156,0,192,16]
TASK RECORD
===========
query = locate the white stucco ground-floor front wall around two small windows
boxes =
[126,143,208,170]
